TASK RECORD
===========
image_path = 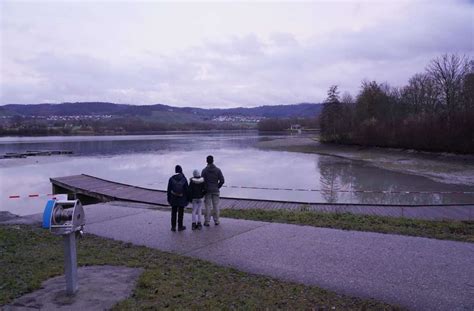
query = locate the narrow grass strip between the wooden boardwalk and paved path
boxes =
[221,209,474,243]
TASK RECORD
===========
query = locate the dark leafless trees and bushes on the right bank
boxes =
[320,54,474,153]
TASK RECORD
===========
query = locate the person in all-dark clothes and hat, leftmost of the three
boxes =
[166,165,188,231]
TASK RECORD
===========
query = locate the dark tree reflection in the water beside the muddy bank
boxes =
[317,156,474,205]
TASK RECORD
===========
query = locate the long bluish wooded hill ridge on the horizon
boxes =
[0,102,322,121]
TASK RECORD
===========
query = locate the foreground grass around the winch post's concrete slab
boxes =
[0,226,399,310]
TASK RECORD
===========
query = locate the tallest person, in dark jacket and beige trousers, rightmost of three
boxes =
[201,155,224,226]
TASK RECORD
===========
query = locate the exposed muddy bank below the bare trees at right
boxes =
[256,136,474,186]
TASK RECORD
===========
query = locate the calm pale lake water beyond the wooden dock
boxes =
[0,133,474,215]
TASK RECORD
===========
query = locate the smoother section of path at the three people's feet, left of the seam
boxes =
[85,204,267,254]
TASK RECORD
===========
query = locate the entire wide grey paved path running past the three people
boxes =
[78,203,474,310]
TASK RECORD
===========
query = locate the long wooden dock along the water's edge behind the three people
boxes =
[50,174,474,220]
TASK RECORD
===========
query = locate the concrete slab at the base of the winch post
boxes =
[3,266,142,311]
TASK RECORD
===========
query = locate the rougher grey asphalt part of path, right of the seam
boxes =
[187,224,474,310]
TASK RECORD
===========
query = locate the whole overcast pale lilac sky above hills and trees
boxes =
[0,0,474,108]
